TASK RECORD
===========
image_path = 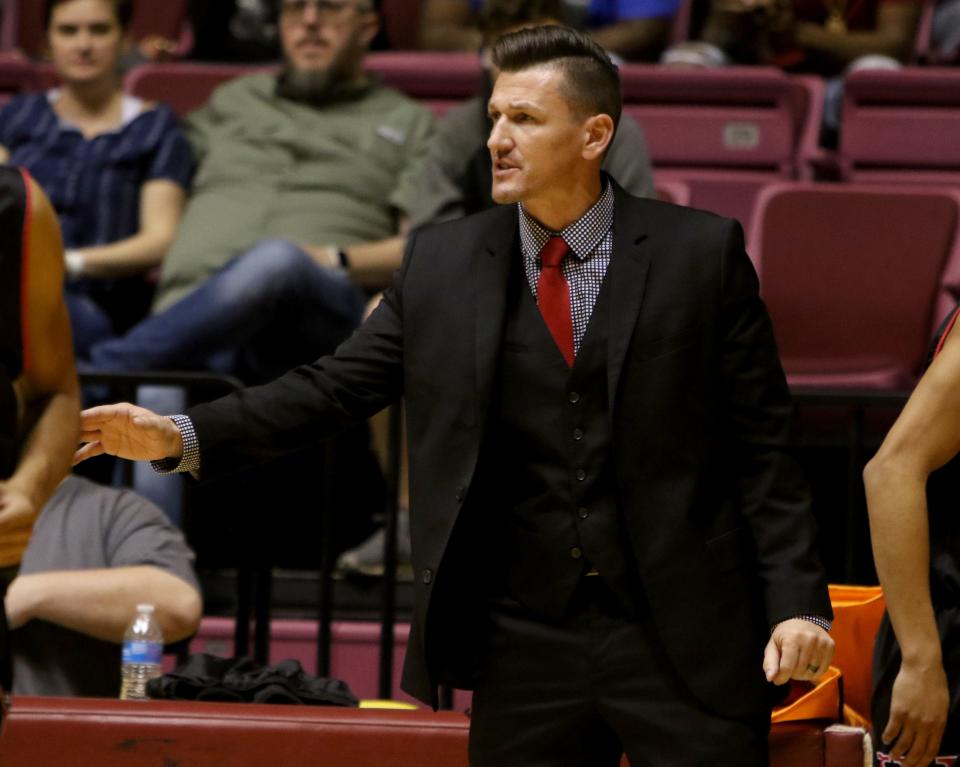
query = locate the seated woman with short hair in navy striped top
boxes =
[0,0,193,355]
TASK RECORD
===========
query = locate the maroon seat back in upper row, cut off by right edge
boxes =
[839,67,960,186]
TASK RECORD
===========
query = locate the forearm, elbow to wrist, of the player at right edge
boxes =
[864,451,941,665]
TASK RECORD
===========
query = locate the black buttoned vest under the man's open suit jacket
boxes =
[473,259,639,618]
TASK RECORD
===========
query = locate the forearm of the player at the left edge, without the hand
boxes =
[7,392,80,513]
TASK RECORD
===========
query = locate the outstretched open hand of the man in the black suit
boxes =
[73,402,183,465]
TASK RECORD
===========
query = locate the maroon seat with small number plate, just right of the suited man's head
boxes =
[621,64,820,234]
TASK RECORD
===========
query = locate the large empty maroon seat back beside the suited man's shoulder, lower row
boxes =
[751,183,960,390]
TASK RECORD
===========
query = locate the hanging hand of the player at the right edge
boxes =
[882,658,950,767]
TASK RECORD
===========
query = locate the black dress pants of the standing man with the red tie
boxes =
[470,577,770,767]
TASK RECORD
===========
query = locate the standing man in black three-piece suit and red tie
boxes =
[77,27,832,767]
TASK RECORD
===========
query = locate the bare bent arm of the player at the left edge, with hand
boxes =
[0,181,80,566]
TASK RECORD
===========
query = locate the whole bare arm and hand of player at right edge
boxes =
[863,332,960,767]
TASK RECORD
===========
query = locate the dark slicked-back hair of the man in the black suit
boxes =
[492,24,623,127]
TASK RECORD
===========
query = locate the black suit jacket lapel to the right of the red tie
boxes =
[606,188,651,417]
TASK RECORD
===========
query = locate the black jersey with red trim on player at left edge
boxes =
[0,167,27,479]
